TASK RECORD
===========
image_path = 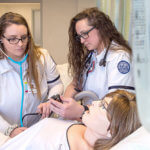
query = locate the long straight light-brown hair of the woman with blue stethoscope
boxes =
[0,12,42,99]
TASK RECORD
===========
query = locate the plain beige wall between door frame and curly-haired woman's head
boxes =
[42,0,96,64]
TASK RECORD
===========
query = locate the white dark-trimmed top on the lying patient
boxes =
[0,118,74,150]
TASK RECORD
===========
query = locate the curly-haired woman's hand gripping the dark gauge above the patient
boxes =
[50,97,84,120]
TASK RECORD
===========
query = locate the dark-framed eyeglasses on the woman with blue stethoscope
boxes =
[3,35,29,44]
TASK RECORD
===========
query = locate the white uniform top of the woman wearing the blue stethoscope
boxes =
[0,49,63,133]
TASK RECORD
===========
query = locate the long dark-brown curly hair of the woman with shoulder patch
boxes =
[68,7,132,84]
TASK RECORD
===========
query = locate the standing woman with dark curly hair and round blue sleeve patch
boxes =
[41,8,134,119]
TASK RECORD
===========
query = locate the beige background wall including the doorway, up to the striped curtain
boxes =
[0,0,97,64]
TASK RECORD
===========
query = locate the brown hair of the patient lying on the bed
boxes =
[94,90,141,150]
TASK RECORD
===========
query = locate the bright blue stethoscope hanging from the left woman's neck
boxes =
[0,48,28,127]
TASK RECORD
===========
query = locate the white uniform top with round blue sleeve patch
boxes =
[83,43,134,104]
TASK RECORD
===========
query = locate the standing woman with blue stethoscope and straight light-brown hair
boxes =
[0,12,63,137]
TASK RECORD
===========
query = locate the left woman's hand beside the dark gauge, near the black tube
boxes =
[36,101,51,119]
